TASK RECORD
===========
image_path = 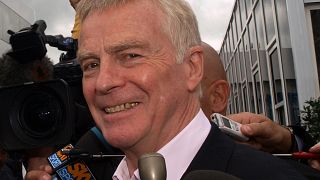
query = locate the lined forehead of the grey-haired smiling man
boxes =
[78,0,174,59]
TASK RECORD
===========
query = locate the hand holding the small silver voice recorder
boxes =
[228,112,292,153]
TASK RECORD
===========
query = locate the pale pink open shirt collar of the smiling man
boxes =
[113,109,211,180]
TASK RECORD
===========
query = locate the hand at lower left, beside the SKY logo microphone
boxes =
[25,147,54,180]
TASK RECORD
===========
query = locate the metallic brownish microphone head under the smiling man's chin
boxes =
[138,153,167,180]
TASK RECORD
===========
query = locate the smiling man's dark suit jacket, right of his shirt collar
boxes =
[184,124,305,180]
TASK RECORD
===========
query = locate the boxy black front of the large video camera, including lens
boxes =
[0,80,74,151]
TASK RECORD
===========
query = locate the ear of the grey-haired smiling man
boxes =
[185,46,203,91]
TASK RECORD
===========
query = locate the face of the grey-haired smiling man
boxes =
[78,1,190,150]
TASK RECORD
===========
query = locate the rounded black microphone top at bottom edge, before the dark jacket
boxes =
[183,170,241,180]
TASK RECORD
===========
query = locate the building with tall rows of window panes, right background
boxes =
[220,0,320,125]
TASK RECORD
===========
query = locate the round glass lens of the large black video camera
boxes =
[19,92,62,138]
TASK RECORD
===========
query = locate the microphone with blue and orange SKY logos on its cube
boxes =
[48,128,124,179]
